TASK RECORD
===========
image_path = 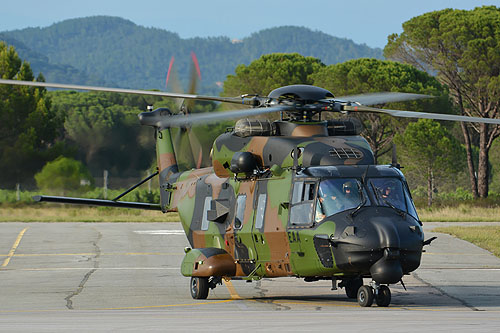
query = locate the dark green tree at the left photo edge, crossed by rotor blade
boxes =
[0,42,65,187]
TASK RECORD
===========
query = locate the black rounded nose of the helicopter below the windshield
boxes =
[331,207,423,284]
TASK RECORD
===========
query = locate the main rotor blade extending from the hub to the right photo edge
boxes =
[343,105,500,124]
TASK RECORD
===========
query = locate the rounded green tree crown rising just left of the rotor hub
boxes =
[222,53,325,96]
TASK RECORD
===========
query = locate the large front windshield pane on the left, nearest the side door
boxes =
[315,178,369,221]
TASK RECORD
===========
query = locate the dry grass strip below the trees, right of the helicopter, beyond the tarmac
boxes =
[417,204,500,222]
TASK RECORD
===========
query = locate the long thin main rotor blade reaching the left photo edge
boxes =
[0,79,247,105]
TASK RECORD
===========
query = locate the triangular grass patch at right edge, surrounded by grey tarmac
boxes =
[432,226,500,258]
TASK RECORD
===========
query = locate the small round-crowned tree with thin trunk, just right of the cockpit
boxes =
[395,119,465,206]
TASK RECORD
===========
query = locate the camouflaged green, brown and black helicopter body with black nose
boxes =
[162,124,423,284]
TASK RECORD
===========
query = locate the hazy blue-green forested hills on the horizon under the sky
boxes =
[0,16,382,93]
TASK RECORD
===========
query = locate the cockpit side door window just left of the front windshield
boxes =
[288,179,318,228]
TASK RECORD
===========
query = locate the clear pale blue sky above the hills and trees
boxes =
[0,0,500,48]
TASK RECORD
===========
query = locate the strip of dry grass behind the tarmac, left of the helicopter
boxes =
[0,204,180,222]
